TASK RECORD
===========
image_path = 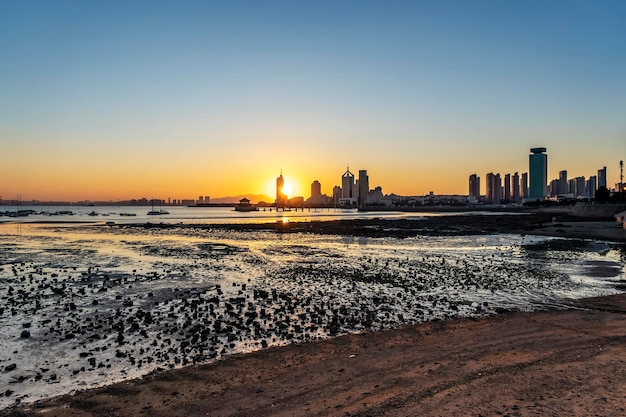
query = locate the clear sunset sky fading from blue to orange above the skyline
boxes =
[0,0,626,201]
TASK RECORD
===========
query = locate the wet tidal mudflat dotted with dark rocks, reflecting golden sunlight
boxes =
[0,224,625,408]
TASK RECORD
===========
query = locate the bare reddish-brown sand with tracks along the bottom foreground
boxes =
[2,295,626,417]
